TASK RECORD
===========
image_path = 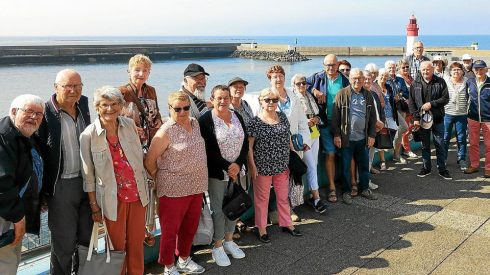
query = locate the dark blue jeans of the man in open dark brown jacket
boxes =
[340,139,369,193]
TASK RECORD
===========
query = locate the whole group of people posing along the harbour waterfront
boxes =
[0,41,490,275]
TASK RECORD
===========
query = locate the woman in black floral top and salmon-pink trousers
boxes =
[248,88,302,243]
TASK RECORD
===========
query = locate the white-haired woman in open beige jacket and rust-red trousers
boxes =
[80,86,148,274]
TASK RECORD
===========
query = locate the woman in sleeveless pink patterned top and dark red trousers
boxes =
[145,92,208,275]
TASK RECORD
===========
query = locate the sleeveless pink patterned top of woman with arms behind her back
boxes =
[156,117,208,197]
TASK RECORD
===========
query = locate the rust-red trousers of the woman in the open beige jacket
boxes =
[106,200,146,275]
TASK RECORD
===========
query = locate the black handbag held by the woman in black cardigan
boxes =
[222,176,252,221]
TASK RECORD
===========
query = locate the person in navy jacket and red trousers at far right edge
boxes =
[465,60,490,178]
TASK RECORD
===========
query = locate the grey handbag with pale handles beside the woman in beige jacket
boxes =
[78,221,126,275]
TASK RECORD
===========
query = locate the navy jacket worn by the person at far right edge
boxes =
[466,77,490,122]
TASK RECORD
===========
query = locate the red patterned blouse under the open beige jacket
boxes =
[107,136,139,202]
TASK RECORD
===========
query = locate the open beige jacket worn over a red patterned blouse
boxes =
[80,116,148,221]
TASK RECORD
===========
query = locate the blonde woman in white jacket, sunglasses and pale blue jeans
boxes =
[291,74,328,209]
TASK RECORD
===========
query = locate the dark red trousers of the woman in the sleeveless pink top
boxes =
[158,194,202,266]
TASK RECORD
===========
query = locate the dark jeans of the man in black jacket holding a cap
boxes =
[420,122,447,172]
